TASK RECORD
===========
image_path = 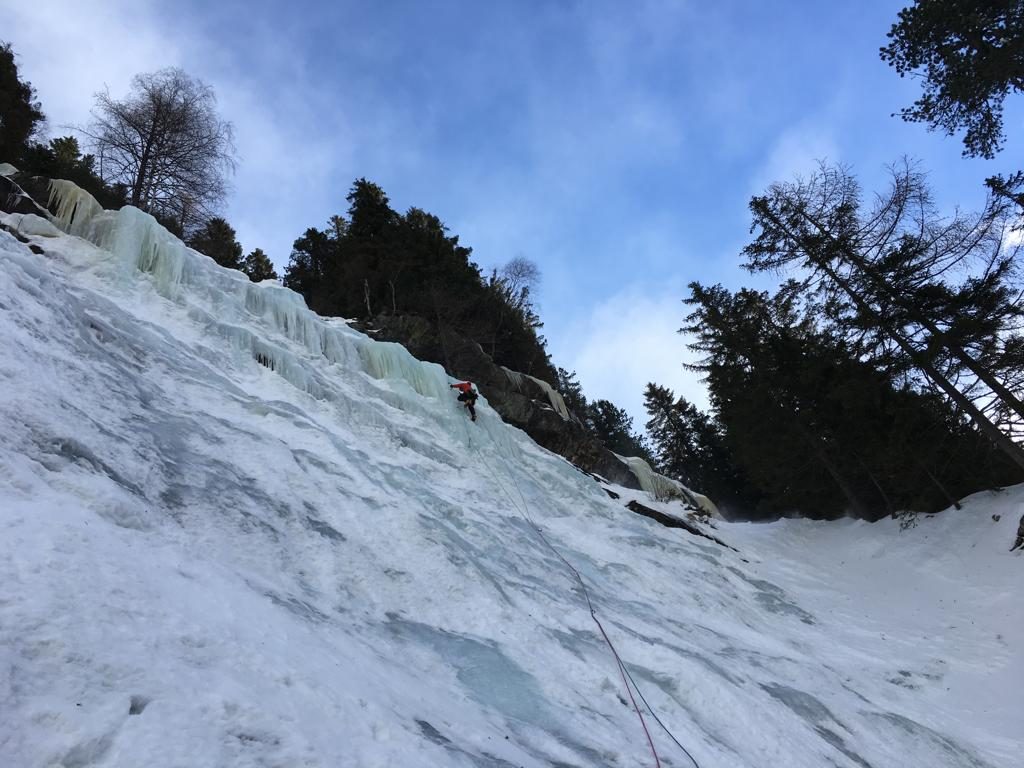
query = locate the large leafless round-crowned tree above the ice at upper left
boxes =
[82,68,236,231]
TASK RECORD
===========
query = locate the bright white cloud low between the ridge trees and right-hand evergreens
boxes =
[552,285,708,431]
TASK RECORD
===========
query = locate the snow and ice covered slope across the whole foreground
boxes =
[0,195,1024,768]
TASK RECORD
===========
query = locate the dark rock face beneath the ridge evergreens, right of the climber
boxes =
[359,315,640,488]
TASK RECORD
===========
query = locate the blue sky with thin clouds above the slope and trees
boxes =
[0,0,1022,426]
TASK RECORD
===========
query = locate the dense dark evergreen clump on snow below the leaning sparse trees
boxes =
[679,281,1020,517]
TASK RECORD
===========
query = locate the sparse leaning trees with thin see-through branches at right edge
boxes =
[743,164,1024,469]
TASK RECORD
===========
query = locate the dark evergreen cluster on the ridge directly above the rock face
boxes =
[284,178,557,386]
